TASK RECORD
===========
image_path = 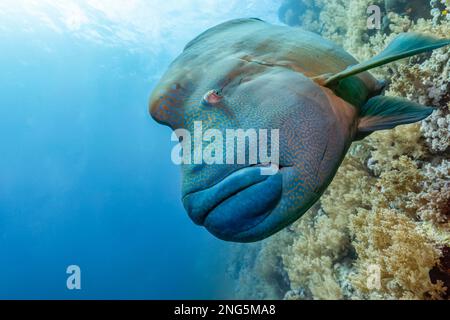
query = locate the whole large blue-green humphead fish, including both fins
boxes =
[150,19,450,242]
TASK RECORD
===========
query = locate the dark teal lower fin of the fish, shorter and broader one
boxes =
[356,96,435,140]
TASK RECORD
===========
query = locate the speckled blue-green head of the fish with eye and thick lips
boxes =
[150,24,354,242]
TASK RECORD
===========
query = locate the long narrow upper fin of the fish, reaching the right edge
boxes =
[315,33,450,87]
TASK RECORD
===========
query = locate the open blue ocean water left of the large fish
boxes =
[0,0,279,299]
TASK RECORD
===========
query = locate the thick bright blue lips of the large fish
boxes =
[183,166,282,241]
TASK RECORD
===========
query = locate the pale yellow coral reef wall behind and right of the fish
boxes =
[232,0,450,299]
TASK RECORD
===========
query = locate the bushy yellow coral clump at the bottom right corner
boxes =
[350,209,445,299]
